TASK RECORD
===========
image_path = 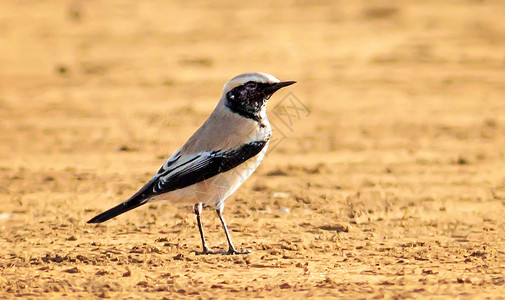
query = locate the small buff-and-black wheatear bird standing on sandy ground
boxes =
[88,73,295,254]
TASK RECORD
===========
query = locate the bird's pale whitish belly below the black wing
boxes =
[153,143,268,209]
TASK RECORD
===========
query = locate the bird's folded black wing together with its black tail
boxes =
[88,141,268,223]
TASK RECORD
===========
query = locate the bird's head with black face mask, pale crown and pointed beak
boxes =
[223,73,296,119]
